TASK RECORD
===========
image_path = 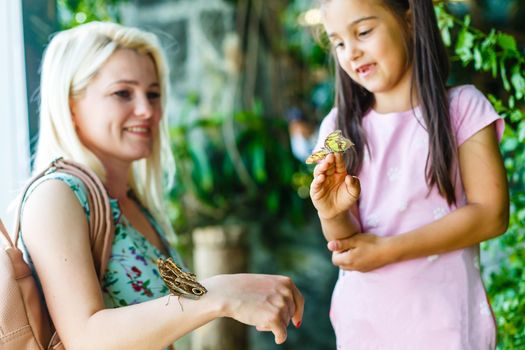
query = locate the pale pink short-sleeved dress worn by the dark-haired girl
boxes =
[316,85,504,350]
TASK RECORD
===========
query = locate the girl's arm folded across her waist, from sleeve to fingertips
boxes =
[328,124,509,271]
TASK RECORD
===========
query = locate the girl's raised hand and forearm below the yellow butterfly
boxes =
[310,153,361,241]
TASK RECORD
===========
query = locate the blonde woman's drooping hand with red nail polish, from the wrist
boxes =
[203,274,304,344]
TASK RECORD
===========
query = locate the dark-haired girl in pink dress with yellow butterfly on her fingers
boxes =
[310,0,509,350]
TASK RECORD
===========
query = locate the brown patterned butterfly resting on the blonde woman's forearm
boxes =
[157,258,208,307]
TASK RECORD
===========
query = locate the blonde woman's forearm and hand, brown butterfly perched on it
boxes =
[63,274,304,349]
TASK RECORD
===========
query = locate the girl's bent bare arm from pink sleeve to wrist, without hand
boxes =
[392,124,509,260]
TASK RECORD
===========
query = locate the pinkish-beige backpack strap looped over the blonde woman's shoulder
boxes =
[13,158,115,282]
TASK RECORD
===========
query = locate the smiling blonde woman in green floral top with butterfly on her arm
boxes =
[21,22,303,349]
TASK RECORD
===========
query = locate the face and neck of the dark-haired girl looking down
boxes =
[322,0,412,110]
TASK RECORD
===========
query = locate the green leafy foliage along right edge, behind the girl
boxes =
[436,5,525,349]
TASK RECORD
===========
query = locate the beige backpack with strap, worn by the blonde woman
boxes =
[0,158,114,350]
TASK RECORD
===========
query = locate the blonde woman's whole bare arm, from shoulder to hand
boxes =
[22,180,304,349]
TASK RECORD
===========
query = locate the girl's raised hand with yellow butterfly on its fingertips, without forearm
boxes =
[310,153,361,219]
